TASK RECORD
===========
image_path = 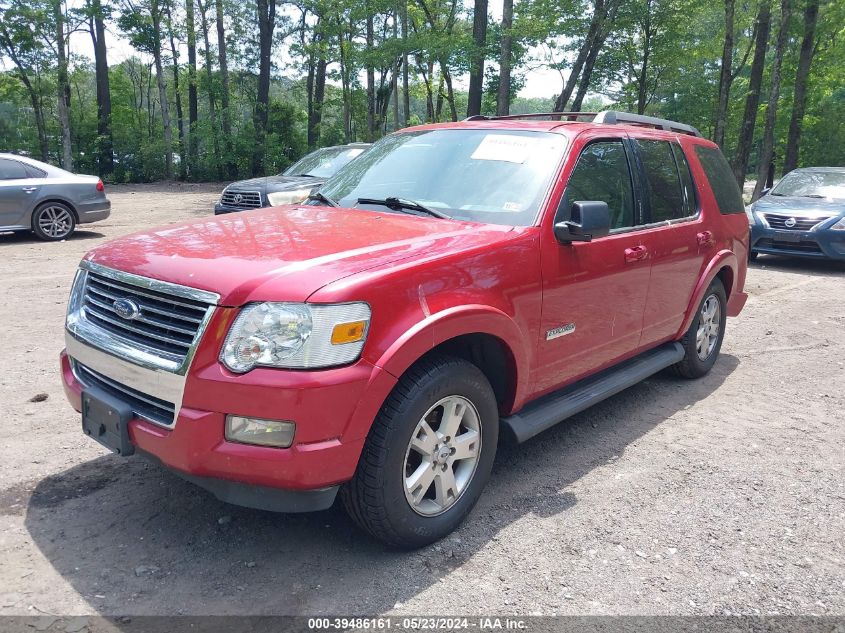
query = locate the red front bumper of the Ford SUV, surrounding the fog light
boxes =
[61,330,395,512]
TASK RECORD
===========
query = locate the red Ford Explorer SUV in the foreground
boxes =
[61,112,748,547]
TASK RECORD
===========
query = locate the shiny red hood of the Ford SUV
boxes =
[86,206,512,306]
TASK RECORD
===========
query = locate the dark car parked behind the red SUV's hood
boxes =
[214,143,370,215]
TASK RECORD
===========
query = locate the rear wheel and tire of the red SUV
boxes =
[672,277,727,378]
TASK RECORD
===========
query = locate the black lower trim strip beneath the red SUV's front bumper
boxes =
[138,451,340,513]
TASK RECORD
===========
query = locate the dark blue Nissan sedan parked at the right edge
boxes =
[747,167,845,260]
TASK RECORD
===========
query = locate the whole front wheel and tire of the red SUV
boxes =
[341,356,499,549]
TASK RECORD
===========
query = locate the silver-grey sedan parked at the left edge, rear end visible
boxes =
[0,154,111,241]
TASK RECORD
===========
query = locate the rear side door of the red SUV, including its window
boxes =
[631,133,715,347]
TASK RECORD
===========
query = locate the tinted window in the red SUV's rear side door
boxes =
[634,140,687,222]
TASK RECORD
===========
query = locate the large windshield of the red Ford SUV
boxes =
[320,129,566,226]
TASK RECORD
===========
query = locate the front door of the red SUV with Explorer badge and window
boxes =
[535,138,651,393]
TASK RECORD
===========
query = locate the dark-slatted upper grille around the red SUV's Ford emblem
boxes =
[82,271,209,363]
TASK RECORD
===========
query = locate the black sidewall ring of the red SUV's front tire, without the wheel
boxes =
[376,362,499,545]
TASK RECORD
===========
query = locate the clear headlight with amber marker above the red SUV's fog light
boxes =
[220,303,370,374]
